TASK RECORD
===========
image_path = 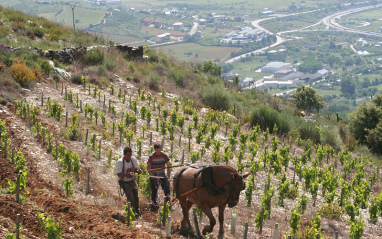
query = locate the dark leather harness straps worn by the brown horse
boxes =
[174,165,243,203]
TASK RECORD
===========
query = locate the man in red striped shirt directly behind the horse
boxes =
[147,143,171,208]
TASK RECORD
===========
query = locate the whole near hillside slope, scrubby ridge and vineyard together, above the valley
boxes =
[0,8,382,238]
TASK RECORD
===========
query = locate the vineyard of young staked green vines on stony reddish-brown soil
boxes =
[0,64,382,238]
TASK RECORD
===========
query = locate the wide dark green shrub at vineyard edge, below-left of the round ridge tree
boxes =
[251,105,290,133]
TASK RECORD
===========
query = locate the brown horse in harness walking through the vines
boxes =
[173,165,250,236]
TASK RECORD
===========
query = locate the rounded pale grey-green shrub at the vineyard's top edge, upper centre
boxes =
[202,85,232,111]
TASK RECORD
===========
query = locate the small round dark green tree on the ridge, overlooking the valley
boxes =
[292,86,324,111]
